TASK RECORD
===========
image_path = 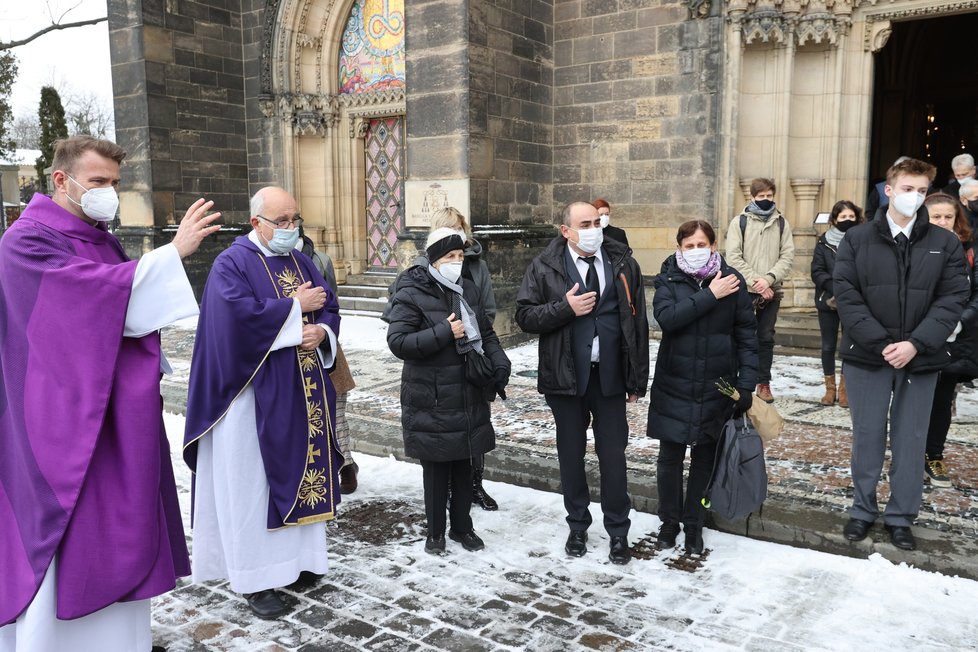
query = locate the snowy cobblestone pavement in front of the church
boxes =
[153,322,978,652]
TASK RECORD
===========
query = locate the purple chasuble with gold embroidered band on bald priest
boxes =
[183,236,343,530]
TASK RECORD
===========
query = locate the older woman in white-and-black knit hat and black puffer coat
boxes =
[387,228,510,554]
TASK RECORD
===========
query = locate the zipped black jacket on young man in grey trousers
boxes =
[833,208,970,373]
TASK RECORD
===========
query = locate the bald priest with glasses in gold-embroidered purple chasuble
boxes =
[184,187,343,618]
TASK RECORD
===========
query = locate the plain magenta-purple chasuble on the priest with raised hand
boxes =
[0,193,190,625]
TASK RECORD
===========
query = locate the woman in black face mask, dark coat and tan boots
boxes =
[812,199,863,407]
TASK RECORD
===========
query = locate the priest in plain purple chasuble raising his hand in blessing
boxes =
[0,136,220,652]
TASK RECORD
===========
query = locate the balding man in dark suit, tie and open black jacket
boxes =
[516,201,649,564]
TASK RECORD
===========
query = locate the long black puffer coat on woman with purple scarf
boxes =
[648,254,757,444]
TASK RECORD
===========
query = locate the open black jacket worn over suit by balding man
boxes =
[516,235,649,396]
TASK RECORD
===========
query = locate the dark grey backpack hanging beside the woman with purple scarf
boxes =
[702,414,767,519]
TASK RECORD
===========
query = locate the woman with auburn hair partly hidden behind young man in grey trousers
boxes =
[924,193,978,487]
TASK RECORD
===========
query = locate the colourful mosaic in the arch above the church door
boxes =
[339,0,405,93]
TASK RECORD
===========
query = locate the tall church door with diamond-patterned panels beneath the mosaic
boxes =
[364,116,404,273]
